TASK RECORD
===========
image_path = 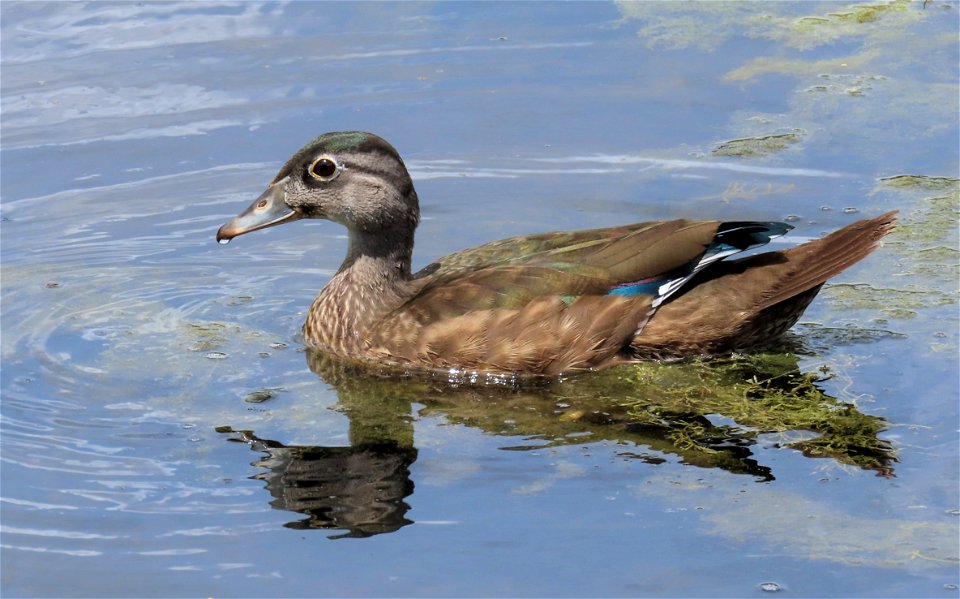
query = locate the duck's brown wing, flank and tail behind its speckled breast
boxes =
[358,213,895,375]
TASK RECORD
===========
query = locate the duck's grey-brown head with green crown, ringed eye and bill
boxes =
[217,131,420,243]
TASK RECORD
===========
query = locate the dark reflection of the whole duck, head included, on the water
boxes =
[218,342,897,538]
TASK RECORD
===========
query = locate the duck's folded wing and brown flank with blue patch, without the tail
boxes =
[373,220,789,374]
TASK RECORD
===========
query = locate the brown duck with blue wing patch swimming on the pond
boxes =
[216,131,897,377]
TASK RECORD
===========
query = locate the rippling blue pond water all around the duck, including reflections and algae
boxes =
[0,2,960,597]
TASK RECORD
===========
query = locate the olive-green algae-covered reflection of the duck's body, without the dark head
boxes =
[308,351,896,478]
